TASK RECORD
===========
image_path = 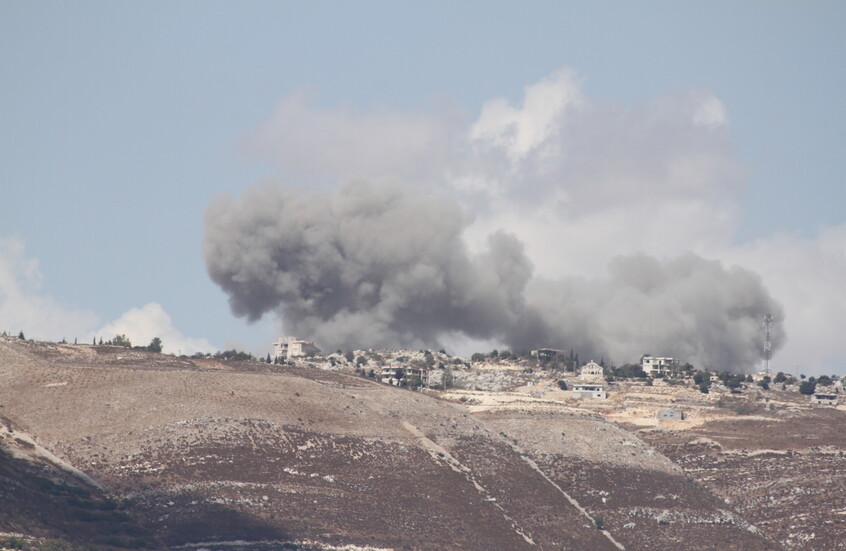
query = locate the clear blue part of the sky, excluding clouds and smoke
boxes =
[0,1,846,371]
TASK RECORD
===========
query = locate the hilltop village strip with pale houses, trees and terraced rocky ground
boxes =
[265,337,846,429]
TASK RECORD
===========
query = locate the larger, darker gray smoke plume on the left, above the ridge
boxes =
[205,182,532,349]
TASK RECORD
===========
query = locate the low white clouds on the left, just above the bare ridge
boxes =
[0,236,215,354]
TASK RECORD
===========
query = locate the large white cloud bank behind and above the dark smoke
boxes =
[227,69,846,373]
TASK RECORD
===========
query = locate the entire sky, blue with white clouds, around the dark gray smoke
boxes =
[0,0,846,373]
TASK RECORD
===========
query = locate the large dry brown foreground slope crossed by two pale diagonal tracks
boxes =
[0,339,777,551]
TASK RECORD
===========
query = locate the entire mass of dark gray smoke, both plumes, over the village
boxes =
[204,182,783,369]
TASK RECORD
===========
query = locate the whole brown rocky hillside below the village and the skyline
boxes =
[0,338,846,551]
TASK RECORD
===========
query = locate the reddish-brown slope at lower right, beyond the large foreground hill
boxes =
[642,407,846,551]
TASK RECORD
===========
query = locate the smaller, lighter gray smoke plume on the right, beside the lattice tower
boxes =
[513,253,784,371]
